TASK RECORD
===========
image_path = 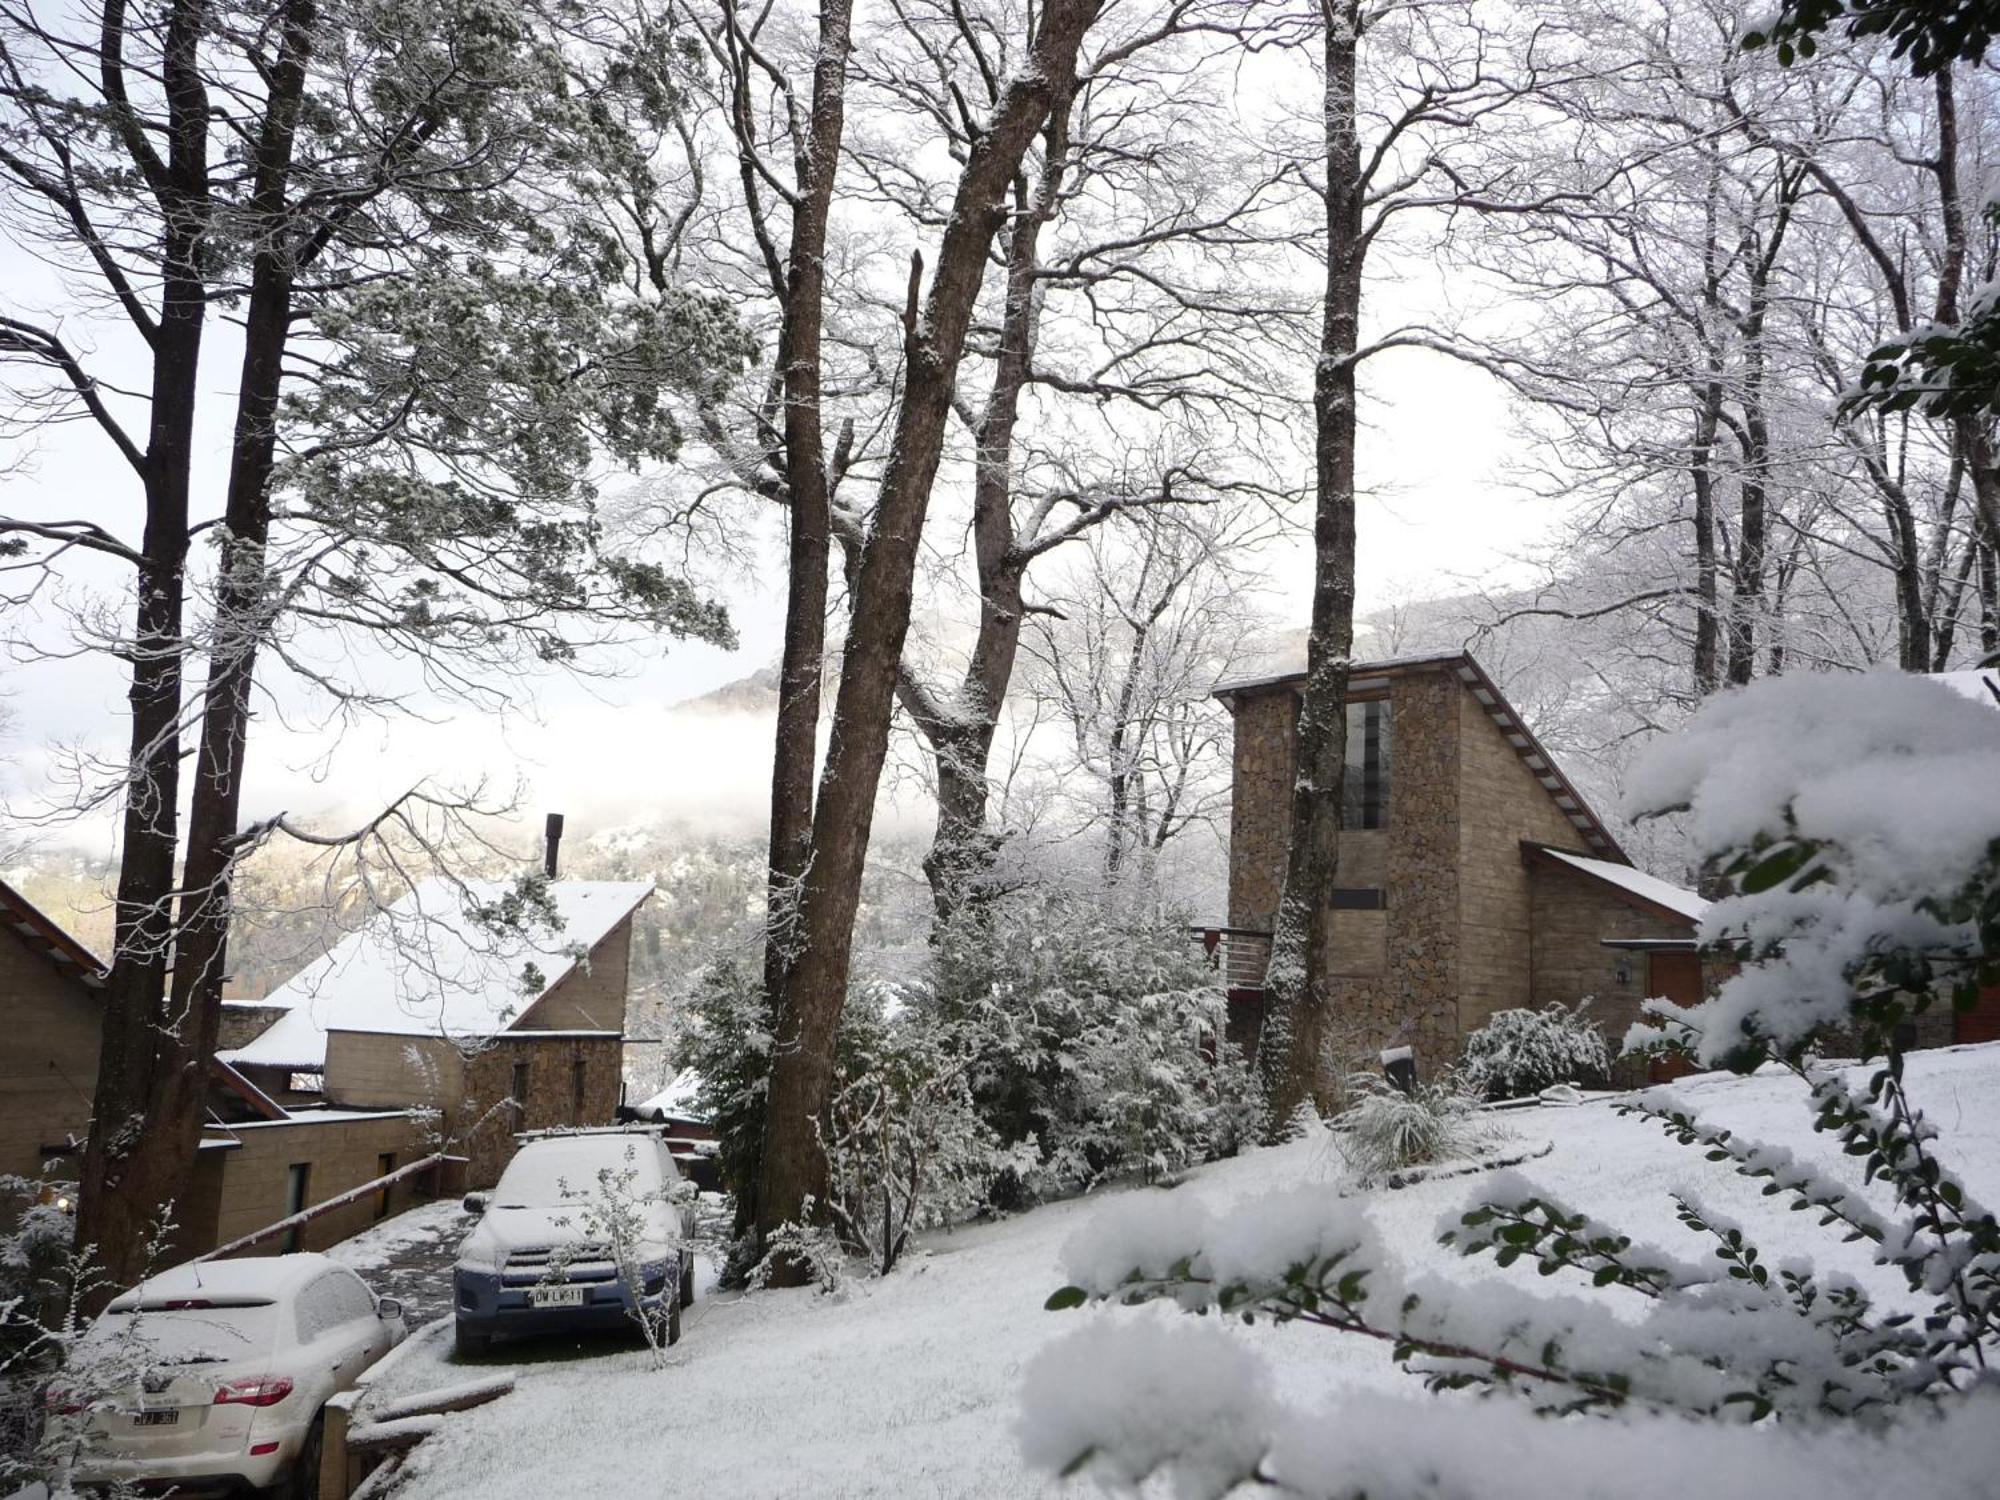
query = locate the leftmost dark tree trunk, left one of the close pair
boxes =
[76,0,210,1310]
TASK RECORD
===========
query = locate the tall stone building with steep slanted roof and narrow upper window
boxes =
[1206,654,1706,1070]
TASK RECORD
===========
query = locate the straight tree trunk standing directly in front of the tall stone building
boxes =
[1258,0,1366,1132]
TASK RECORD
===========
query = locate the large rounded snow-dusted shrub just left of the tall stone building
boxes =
[930,888,1258,1208]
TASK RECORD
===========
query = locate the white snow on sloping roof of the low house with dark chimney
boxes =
[218,880,652,1070]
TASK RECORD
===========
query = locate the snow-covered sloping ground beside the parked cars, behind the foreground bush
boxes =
[364,1046,2000,1500]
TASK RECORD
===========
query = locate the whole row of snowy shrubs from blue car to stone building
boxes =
[674,888,1258,1272]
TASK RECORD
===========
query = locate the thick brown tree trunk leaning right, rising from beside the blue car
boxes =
[756,0,1102,1282]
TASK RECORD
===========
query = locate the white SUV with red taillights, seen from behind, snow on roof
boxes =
[48,1254,406,1496]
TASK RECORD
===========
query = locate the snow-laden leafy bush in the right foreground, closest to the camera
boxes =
[1022,674,2000,1500]
